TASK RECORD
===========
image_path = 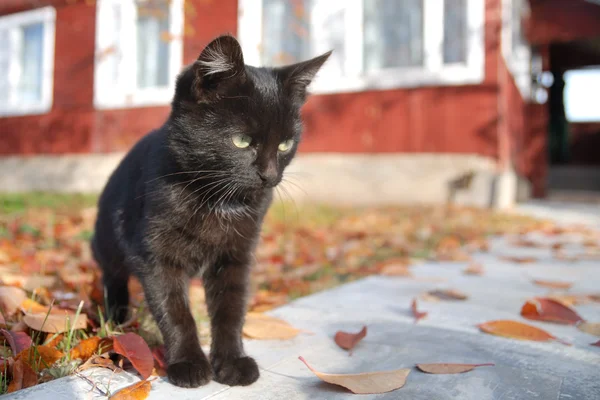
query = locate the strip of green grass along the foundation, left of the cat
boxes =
[0,192,98,215]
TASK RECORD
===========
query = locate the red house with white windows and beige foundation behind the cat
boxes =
[0,0,600,206]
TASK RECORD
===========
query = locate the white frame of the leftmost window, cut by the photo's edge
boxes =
[0,6,56,117]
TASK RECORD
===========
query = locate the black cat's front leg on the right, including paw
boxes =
[203,258,259,386]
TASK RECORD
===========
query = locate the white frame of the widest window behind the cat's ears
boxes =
[238,0,485,94]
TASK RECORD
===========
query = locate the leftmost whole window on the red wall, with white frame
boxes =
[0,7,56,116]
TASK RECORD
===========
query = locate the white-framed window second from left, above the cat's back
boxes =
[94,0,183,108]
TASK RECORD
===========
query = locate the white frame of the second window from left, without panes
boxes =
[94,0,184,109]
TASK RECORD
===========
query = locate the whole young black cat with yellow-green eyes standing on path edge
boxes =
[92,35,331,387]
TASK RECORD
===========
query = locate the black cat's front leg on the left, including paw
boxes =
[141,266,212,387]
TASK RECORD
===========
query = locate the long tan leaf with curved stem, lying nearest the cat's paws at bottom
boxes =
[298,357,410,394]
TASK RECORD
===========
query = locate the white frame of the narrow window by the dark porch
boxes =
[501,0,532,101]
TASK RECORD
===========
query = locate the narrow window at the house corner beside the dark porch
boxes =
[502,0,532,100]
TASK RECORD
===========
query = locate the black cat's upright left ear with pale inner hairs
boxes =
[192,35,246,103]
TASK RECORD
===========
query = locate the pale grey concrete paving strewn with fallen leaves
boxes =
[6,227,600,400]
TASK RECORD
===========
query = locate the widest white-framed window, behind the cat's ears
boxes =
[238,0,485,93]
